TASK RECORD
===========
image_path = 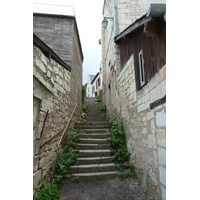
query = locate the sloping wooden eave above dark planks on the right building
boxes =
[114,14,152,43]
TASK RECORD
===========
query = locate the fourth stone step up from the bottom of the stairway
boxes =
[79,149,111,157]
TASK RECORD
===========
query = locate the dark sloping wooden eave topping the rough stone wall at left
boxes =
[33,33,71,72]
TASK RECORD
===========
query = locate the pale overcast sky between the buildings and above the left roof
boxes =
[33,0,104,84]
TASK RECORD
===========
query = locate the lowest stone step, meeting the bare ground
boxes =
[64,171,118,181]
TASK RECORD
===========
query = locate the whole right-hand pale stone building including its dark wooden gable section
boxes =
[101,0,166,199]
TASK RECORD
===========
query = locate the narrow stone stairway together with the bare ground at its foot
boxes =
[60,98,148,200]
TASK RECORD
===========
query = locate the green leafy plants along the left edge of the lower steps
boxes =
[33,131,79,200]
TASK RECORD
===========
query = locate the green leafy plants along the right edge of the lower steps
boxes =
[109,114,137,178]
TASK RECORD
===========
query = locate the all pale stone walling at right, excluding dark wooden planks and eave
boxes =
[101,0,166,200]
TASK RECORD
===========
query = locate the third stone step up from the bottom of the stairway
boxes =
[78,156,113,165]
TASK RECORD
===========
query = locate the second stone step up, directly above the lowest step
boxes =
[68,163,117,174]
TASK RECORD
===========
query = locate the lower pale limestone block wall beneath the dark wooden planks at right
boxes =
[106,55,166,199]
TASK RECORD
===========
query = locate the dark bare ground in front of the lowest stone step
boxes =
[60,177,149,200]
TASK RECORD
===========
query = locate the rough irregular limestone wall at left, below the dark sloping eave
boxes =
[33,45,71,187]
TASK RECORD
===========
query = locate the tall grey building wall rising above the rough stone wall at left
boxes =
[33,13,83,121]
